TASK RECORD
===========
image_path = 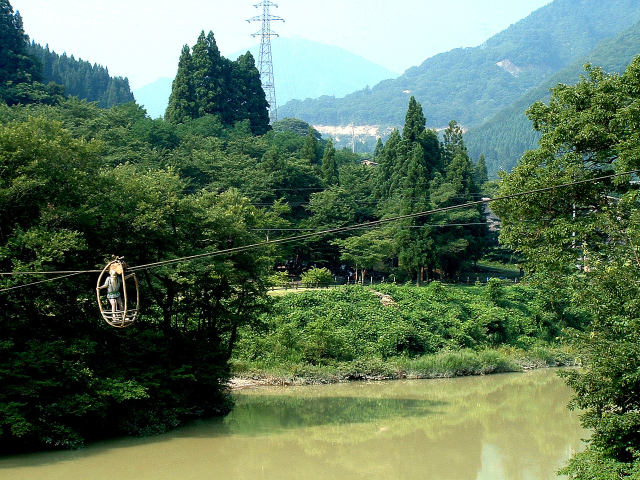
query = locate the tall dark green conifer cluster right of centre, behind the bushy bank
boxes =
[336,101,487,283]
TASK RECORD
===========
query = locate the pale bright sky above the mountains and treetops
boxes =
[10,0,551,88]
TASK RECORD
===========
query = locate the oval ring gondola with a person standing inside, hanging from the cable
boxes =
[96,257,140,328]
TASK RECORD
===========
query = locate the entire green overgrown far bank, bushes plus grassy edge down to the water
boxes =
[232,280,585,383]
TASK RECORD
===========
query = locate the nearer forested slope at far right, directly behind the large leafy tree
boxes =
[465,22,640,175]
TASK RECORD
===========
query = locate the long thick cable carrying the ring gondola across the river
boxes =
[0,170,640,293]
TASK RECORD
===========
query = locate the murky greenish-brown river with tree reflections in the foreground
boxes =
[0,370,586,480]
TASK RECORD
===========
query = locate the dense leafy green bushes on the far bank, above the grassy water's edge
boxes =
[234,279,585,370]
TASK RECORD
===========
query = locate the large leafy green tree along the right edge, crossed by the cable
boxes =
[495,57,640,479]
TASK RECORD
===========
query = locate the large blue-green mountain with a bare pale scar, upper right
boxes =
[279,0,640,127]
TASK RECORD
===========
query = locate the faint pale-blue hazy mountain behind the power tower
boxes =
[133,38,398,117]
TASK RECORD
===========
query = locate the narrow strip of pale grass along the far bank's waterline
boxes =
[229,347,580,390]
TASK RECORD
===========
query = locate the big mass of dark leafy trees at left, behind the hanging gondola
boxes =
[0,104,276,450]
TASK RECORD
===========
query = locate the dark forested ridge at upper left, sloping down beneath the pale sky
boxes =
[28,42,133,108]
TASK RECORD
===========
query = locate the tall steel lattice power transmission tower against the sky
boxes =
[247,0,284,123]
